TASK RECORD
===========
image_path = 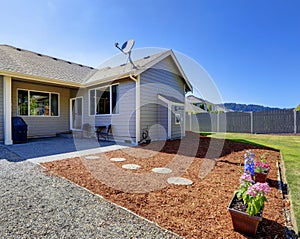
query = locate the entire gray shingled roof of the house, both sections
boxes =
[0,45,192,91]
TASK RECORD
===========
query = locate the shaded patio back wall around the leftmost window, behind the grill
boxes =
[12,79,70,137]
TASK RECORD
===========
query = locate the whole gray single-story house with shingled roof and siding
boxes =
[0,45,192,144]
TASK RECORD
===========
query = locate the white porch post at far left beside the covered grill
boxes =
[3,76,13,145]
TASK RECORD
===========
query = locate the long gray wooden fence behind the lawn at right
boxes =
[185,110,300,134]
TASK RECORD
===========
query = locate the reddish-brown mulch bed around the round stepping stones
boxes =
[42,133,285,238]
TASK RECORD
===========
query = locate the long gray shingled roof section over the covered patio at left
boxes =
[0,45,97,85]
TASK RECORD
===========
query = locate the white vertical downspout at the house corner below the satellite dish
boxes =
[129,74,141,144]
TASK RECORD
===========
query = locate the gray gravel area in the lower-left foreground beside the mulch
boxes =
[0,160,181,238]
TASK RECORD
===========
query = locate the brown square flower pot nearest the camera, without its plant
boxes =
[228,195,262,236]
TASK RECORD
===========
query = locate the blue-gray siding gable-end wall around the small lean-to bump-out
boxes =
[141,57,185,140]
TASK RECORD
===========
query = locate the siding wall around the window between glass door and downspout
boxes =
[77,79,135,142]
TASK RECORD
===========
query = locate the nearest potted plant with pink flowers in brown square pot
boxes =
[228,173,270,236]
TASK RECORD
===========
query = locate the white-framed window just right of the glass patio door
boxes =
[89,85,119,115]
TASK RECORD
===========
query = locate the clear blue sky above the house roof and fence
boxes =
[0,0,300,108]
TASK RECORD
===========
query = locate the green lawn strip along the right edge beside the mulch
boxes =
[211,133,300,233]
